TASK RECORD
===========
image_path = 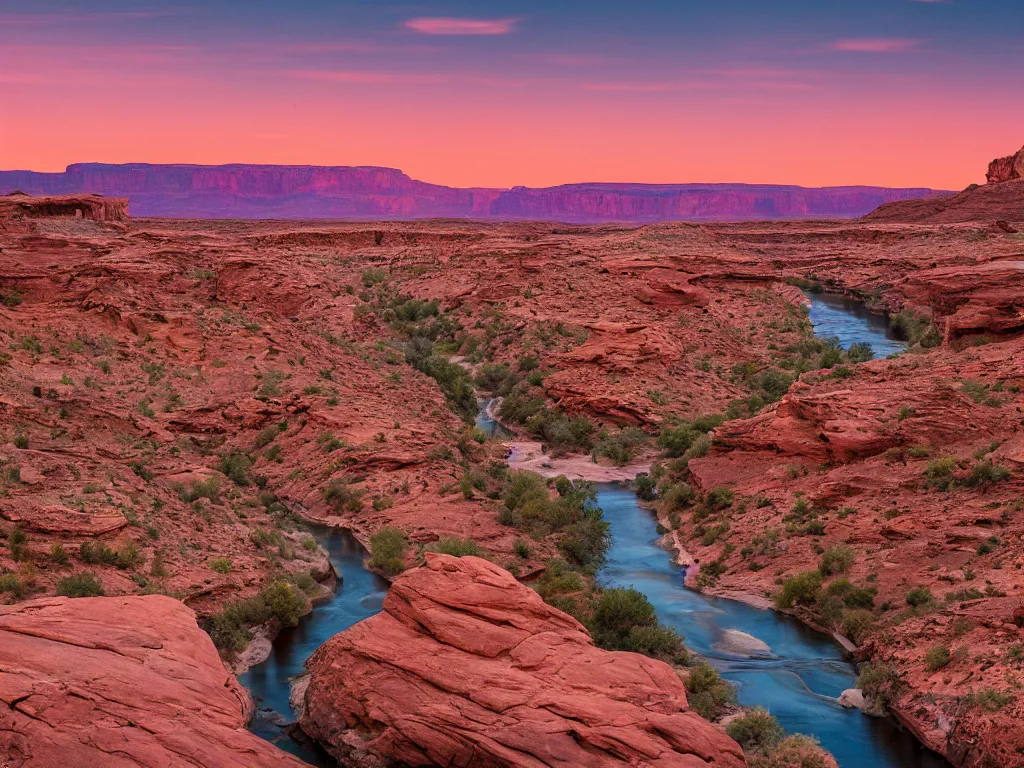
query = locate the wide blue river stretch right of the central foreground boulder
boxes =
[597,484,948,768]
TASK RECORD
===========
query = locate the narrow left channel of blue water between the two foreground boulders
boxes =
[239,528,388,768]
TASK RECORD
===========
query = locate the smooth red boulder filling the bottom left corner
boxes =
[0,595,305,768]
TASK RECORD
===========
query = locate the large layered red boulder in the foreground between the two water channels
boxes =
[301,554,745,768]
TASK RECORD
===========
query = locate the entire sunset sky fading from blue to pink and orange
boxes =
[0,0,1024,189]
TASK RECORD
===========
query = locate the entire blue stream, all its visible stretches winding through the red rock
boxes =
[239,294,948,768]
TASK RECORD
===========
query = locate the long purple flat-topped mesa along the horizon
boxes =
[0,163,942,223]
